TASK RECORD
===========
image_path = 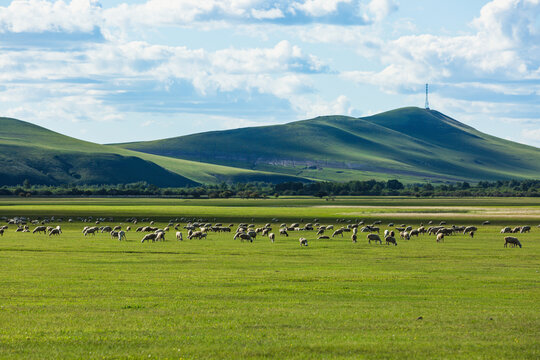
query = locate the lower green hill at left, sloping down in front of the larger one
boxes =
[0,118,306,186]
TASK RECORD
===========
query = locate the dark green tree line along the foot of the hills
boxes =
[0,180,540,200]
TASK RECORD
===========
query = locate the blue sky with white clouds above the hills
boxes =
[0,0,540,147]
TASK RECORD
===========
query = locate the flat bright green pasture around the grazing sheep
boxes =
[0,198,540,359]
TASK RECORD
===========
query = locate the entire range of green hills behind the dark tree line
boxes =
[0,108,540,187]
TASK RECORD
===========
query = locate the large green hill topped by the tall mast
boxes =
[115,108,540,181]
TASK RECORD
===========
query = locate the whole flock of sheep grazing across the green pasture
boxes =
[0,217,540,248]
